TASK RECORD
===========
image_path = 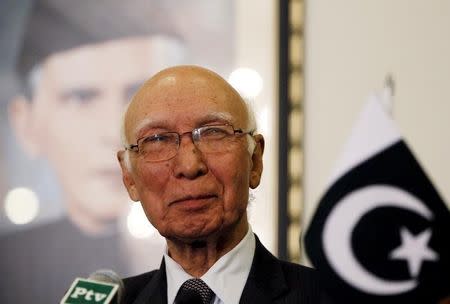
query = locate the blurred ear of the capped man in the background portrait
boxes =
[8,95,41,158]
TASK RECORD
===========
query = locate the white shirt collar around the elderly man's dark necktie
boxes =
[164,226,255,304]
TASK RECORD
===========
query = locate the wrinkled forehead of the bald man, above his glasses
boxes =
[125,75,248,140]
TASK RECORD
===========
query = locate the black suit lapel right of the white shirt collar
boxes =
[239,236,288,304]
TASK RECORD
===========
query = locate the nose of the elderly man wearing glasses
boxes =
[174,136,208,179]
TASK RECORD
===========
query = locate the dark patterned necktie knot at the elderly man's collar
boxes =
[175,279,214,304]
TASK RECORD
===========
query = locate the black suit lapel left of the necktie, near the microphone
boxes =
[133,258,167,304]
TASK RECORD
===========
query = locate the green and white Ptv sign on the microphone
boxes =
[60,278,119,304]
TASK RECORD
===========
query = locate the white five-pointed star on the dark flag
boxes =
[389,227,439,277]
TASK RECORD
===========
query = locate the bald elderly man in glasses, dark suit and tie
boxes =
[118,66,319,304]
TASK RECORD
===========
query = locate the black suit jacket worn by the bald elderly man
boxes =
[123,237,320,304]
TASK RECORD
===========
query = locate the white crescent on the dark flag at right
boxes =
[323,185,433,295]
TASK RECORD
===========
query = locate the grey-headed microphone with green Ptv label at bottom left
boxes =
[60,269,125,304]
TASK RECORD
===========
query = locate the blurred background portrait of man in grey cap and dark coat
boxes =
[0,0,232,303]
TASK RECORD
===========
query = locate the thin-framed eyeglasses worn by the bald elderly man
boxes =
[125,125,254,162]
